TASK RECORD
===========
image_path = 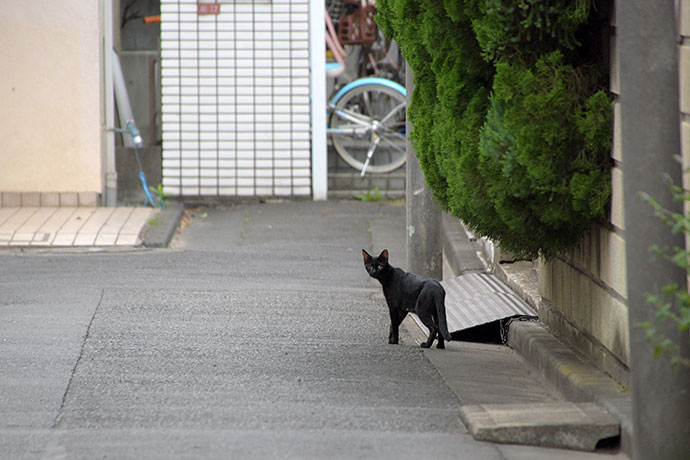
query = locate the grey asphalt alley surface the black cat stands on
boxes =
[0,201,626,460]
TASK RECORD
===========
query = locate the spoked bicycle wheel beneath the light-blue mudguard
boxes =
[329,83,407,175]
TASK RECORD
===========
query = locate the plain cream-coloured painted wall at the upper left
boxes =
[0,0,102,194]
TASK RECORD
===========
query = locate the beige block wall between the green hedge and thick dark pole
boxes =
[539,0,632,386]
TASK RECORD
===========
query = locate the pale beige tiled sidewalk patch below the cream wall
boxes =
[0,207,156,247]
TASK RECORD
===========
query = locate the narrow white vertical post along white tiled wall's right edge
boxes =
[309,0,328,200]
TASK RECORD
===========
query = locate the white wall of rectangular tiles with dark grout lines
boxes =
[161,0,311,195]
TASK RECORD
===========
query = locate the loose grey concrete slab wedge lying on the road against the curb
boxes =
[460,402,620,451]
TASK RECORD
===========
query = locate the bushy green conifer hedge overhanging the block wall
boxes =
[377,0,612,257]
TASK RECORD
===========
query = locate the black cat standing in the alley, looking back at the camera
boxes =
[362,249,451,348]
